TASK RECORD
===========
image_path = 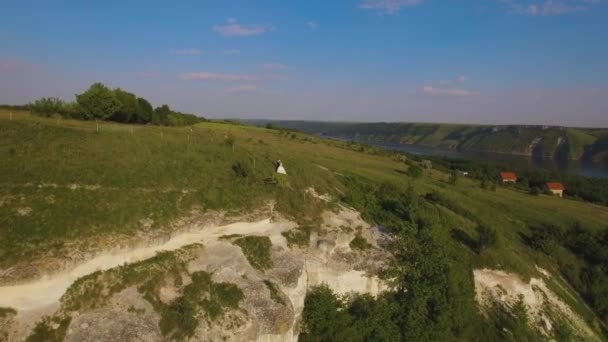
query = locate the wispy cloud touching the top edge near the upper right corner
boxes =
[500,0,601,16]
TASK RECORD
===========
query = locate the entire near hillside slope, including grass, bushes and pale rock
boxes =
[0,112,608,341]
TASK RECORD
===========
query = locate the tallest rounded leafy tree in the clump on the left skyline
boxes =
[76,83,121,120]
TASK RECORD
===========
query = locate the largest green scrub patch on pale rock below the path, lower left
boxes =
[59,245,244,340]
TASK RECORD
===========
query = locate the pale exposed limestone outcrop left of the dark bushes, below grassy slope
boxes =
[0,207,389,341]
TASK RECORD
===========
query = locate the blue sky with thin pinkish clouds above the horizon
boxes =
[0,0,608,127]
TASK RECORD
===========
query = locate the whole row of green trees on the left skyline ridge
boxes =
[25,83,206,126]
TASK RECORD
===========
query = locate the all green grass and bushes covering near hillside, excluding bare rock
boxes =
[0,111,608,341]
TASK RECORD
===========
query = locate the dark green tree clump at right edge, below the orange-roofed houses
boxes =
[524,224,608,323]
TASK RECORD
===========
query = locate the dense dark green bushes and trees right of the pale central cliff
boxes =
[308,177,497,341]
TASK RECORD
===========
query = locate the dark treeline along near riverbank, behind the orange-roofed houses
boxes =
[425,157,608,205]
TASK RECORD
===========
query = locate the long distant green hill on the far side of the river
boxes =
[249,120,608,162]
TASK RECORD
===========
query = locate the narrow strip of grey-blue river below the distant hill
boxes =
[346,141,608,178]
